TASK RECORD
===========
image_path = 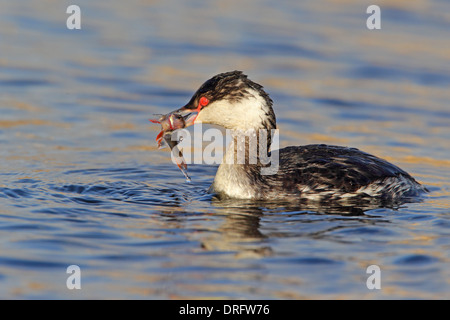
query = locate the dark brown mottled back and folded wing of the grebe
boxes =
[266,145,415,193]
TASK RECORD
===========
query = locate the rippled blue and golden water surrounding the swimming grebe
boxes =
[0,0,450,299]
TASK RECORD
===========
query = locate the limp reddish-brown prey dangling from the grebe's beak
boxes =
[150,112,191,182]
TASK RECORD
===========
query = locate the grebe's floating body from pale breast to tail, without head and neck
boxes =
[211,144,425,201]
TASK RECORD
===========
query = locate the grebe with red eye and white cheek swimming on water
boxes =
[153,71,427,201]
